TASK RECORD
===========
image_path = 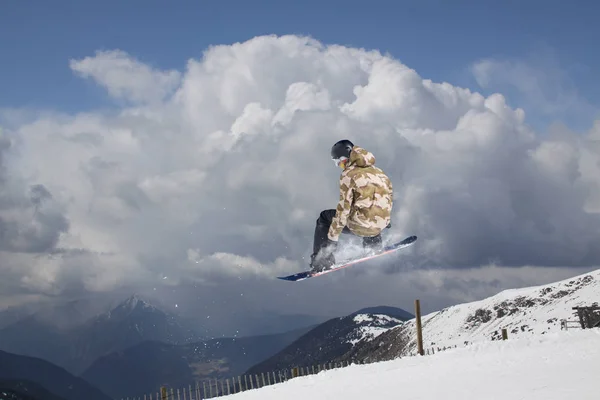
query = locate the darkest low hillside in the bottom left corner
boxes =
[0,351,111,400]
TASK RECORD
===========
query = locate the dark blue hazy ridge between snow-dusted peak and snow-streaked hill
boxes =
[81,328,310,398]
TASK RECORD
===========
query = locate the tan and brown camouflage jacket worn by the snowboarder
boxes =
[327,146,393,241]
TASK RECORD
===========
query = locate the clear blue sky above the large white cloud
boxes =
[0,0,600,129]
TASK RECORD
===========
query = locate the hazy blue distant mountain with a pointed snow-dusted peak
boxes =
[0,296,200,375]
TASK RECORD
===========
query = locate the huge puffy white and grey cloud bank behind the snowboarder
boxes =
[0,36,600,310]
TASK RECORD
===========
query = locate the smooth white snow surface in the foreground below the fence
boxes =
[226,329,600,400]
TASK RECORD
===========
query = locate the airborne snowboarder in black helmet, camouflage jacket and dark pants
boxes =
[310,139,393,271]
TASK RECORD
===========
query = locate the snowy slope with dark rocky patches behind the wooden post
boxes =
[397,270,600,353]
